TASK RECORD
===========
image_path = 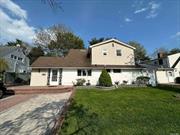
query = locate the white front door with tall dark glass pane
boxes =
[50,69,59,85]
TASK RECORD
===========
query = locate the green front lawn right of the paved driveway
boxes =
[60,88,180,135]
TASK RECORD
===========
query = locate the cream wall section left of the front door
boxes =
[30,69,48,86]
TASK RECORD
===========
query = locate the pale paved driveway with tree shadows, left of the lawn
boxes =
[0,92,71,135]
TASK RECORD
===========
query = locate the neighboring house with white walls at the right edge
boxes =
[141,53,180,83]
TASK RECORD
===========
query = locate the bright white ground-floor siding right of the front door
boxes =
[62,69,155,85]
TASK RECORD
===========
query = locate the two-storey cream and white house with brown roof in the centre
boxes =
[30,39,155,86]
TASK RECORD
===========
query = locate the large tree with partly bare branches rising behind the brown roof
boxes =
[34,24,84,56]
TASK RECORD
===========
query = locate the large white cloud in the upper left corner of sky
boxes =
[0,0,35,43]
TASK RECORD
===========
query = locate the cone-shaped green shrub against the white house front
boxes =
[99,69,112,87]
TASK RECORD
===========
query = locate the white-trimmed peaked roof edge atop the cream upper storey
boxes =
[90,38,136,50]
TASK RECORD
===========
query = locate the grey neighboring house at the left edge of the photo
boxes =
[0,46,30,73]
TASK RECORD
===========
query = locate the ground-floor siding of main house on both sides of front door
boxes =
[30,68,155,86]
